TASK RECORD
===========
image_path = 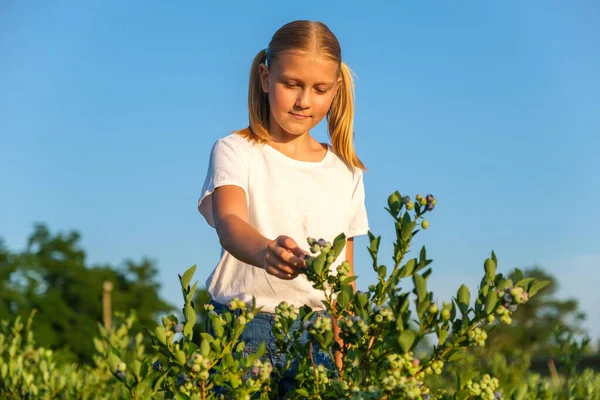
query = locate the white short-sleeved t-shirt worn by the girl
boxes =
[198,134,369,313]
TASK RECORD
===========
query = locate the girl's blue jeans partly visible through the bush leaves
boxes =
[206,301,335,396]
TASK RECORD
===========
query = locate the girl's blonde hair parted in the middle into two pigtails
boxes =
[236,21,366,171]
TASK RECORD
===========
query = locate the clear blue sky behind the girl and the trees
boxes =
[0,1,600,337]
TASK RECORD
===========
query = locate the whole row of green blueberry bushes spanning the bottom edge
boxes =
[0,192,600,400]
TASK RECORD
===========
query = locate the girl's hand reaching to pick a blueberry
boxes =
[264,235,308,280]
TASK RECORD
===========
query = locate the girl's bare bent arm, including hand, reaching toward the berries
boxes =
[212,185,304,279]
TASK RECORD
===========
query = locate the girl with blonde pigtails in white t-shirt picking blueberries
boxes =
[198,21,368,394]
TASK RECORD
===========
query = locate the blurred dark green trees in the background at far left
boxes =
[0,224,173,363]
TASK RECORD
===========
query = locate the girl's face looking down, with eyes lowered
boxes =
[260,51,341,139]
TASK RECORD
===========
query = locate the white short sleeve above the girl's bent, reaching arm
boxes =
[198,137,248,228]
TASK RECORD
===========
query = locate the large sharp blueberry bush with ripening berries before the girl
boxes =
[97,192,549,399]
